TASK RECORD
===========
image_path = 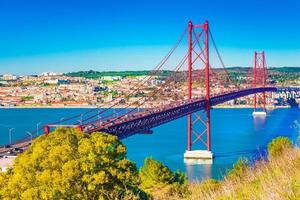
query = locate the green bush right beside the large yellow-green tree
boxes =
[139,158,187,196]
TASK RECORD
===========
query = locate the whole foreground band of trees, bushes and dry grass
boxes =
[0,128,300,200]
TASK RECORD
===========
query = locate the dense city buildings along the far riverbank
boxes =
[0,68,300,107]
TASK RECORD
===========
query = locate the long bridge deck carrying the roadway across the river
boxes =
[0,87,300,157]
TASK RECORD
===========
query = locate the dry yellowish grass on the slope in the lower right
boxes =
[154,145,300,200]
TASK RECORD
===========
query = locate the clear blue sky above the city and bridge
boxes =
[0,0,300,74]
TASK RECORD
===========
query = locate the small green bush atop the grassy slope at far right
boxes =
[268,137,293,159]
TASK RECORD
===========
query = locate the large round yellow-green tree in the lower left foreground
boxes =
[0,128,142,199]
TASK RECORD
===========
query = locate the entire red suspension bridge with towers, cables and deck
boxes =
[2,21,299,158]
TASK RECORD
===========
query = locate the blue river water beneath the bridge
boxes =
[0,108,300,181]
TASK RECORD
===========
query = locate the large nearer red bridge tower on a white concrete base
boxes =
[184,21,213,159]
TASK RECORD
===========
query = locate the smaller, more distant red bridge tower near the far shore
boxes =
[253,51,267,116]
